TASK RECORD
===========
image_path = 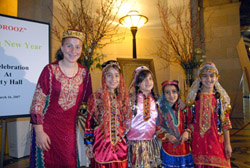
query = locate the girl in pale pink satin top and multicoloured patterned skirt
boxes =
[127,66,161,168]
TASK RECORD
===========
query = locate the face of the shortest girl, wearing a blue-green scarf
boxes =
[164,85,178,106]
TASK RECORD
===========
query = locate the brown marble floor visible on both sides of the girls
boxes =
[1,119,250,168]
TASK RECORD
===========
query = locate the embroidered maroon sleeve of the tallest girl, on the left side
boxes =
[30,65,52,124]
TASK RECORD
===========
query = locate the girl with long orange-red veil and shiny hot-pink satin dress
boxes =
[85,60,131,168]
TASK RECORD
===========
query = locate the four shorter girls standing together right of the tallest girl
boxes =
[85,60,232,168]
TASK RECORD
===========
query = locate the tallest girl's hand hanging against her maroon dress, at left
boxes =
[36,131,51,151]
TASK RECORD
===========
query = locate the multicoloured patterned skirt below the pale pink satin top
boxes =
[127,139,161,168]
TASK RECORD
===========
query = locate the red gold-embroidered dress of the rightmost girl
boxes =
[189,93,232,167]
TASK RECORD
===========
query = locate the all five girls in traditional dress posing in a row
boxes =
[30,29,232,168]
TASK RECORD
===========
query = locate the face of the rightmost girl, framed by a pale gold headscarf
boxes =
[200,71,218,93]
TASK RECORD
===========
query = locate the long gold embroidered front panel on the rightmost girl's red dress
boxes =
[200,94,212,138]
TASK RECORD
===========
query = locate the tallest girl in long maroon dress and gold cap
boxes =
[30,29,92,168]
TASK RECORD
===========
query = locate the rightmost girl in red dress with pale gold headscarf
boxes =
[187,62,232,168]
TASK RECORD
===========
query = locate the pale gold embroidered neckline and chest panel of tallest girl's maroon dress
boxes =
[55,66,86,111]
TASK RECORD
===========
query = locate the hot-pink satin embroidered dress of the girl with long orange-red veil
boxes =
[85,89,129,168]
